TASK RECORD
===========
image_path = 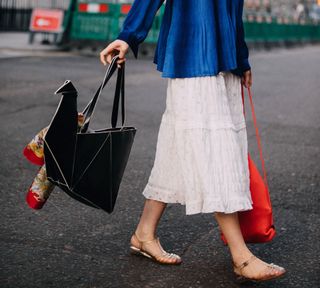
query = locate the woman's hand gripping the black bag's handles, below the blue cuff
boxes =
[100,39,129,68]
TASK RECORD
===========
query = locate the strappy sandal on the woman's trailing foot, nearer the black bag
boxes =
[130,233,182,265]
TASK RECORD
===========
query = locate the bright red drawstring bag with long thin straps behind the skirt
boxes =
[220,86,276,244]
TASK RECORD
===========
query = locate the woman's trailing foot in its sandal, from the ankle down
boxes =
[130,233,182,264]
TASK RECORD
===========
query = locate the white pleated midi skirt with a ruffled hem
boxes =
[142,72,252,215]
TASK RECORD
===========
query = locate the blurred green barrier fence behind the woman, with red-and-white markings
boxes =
[67,0,320,43]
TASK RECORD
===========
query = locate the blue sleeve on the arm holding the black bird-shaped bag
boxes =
[117,0,164,58]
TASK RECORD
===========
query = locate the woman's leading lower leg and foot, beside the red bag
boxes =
[214,212,284,279]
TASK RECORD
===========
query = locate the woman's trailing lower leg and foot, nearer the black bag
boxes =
[131,199,181,264]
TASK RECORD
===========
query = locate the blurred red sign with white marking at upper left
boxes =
[30,9,63,32]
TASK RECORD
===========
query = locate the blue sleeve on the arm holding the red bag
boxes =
[237,0,251,73]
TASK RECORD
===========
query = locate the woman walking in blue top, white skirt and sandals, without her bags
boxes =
[100,0,285,281]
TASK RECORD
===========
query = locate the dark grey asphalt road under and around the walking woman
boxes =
[0,46,320,288]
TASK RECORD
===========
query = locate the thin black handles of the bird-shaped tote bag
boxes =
[80,55,125,133]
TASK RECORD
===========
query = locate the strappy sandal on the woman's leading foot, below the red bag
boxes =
[233,255,286,283]
